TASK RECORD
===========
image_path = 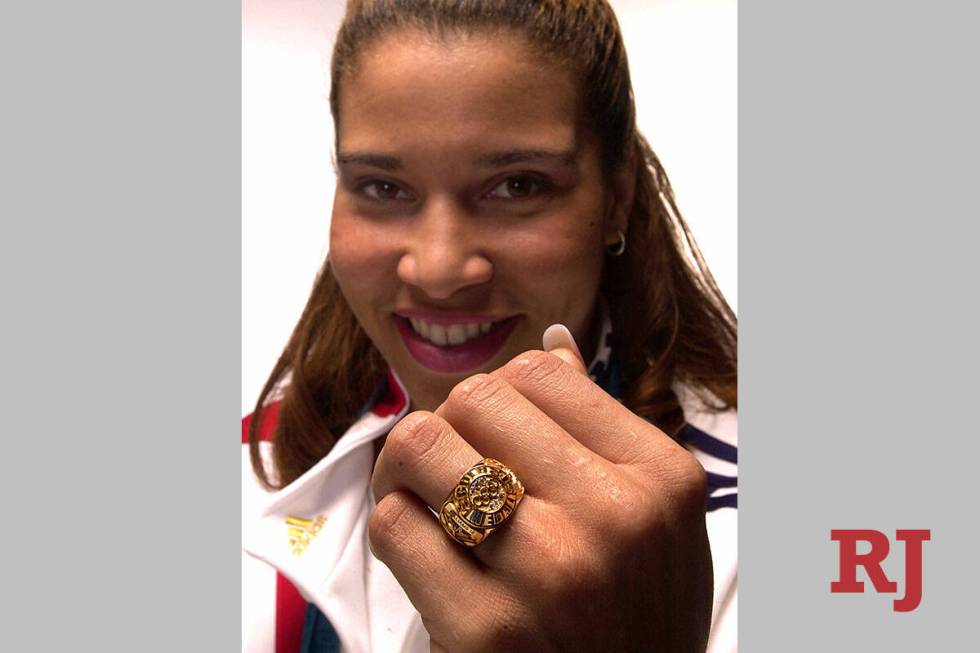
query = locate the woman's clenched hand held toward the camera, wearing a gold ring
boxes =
[368,344,712,653]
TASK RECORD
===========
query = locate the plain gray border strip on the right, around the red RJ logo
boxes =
[739,0,980,652]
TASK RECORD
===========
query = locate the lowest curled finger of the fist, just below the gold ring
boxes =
[368,491,486,647]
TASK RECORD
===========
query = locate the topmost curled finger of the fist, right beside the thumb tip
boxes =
[494,351,680,464]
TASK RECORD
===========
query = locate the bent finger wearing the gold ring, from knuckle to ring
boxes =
[371,411,483,511]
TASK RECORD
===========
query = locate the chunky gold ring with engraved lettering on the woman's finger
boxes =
[439,458,524,546]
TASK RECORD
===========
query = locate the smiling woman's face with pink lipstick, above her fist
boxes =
[330,31,617,410]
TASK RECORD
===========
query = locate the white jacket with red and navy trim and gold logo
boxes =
[242,364,738,653]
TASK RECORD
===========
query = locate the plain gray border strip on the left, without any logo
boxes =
[0,2,241,651]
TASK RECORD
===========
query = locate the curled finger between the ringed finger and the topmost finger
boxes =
[436,370,610,496]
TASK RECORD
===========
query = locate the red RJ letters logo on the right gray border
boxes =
[830,529,931,612]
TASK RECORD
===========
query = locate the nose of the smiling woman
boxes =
[398,199,493,299]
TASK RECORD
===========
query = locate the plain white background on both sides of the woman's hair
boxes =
[242,0,738,414]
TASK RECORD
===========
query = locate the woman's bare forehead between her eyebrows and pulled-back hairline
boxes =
[338,30,581,158]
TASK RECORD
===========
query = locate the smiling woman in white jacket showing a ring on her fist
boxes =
[243,0,737,652]
